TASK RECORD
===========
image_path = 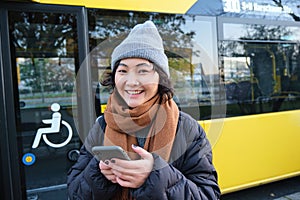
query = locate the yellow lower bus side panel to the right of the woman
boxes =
[201,110,300,193]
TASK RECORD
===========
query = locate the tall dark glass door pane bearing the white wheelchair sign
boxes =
[9,12,81,199]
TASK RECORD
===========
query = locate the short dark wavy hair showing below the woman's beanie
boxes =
[100,61,174,103]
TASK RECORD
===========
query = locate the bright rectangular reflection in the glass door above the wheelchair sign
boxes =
[17,57,75,108]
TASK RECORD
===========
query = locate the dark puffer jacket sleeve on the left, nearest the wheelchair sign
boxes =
[67,123,121,200]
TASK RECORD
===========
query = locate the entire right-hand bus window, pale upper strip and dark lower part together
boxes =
[220,24,300,116]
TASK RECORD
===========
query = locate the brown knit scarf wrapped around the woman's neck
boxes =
[104,91,179,199]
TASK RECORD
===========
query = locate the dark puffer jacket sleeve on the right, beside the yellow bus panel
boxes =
[133,115,220,200]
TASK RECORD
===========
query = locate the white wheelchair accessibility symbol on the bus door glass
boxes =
[32,103,73,149]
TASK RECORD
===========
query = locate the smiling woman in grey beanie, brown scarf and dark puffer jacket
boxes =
[68,21,220,200]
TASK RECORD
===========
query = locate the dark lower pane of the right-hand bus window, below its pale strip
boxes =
[220,41,300,116]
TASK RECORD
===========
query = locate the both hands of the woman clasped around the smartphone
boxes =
[99,145,154,188]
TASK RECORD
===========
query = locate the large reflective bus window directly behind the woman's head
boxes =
[89,9,220,119]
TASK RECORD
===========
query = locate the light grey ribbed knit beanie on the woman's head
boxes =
[111,21,170,77]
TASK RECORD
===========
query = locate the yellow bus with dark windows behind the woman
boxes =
[0,0,300,199]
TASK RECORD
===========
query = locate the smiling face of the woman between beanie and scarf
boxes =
[115,58,159,108]
